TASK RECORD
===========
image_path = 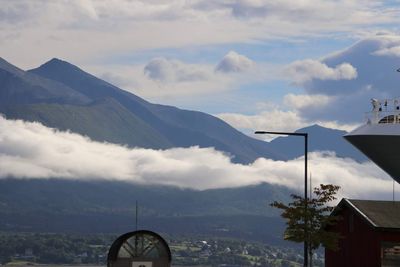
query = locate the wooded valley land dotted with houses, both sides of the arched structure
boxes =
[0,233,323,267]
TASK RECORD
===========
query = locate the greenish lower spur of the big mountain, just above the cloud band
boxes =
[5,98,172,148]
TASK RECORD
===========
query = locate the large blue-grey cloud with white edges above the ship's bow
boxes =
[286,32,400,124]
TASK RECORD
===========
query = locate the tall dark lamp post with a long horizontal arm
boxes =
[255,131,308,267]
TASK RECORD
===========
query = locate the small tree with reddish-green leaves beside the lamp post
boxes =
[271,184,340,263]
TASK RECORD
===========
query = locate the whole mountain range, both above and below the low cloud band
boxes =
[0,58,366,243]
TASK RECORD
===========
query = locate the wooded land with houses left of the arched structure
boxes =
[0,233,115,264]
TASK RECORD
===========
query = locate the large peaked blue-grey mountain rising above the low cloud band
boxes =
[0,59,284,163]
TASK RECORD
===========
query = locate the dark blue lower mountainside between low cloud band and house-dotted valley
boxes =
[0,179,289,246]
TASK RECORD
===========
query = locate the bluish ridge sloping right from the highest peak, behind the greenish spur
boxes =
[25,59,284,163]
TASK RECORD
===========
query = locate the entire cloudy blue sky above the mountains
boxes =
[0,0,400,132]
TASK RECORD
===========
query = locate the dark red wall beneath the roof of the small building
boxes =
[325,207,400,267]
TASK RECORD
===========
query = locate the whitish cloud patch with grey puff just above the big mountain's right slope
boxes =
[87,60,231,99]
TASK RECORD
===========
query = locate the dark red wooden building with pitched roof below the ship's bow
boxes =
[325,198,400,267]
